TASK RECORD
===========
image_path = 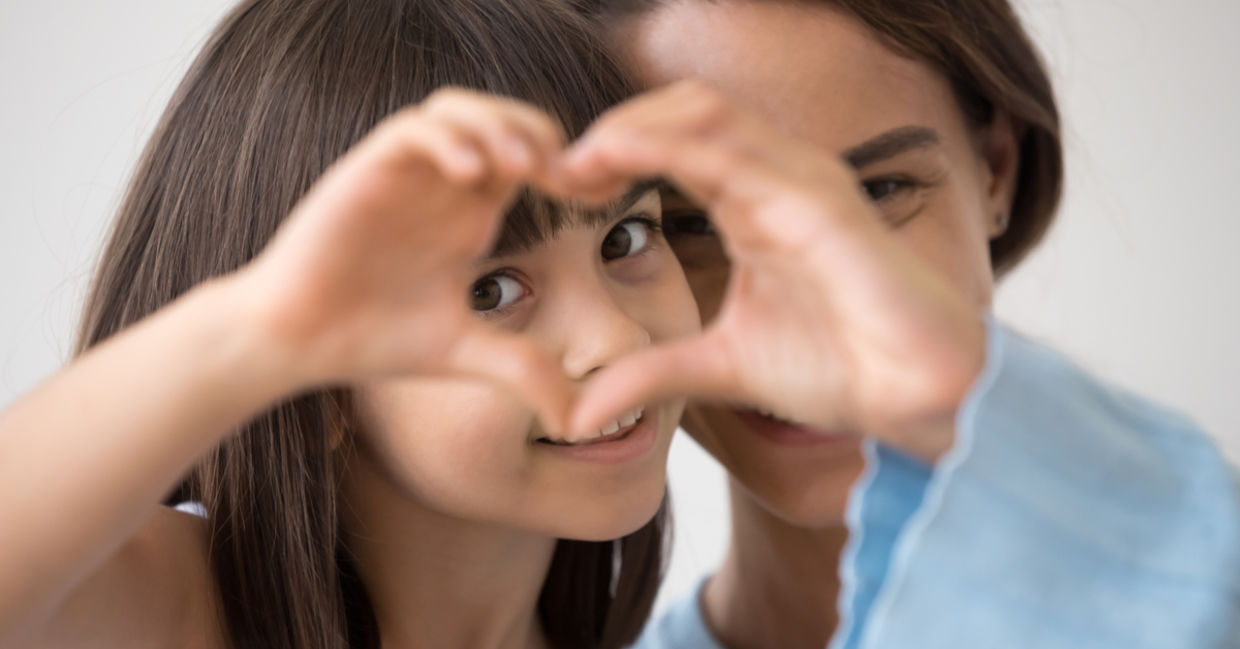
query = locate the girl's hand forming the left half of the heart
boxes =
[234,89,572,426]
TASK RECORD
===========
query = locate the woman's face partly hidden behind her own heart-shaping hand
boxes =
[609,0,1016,527]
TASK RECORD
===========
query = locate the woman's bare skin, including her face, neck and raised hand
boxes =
[558,0,1018,649]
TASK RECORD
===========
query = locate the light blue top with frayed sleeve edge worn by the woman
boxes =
[637,320,1240,649]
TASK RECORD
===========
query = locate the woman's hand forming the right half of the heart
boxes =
[556,82,986,459]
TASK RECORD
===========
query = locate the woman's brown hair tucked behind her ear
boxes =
[572,0,1064,275]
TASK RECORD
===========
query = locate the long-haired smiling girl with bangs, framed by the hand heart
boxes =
[0,0,698,649]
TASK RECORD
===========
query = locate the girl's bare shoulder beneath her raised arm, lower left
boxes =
[38,508,228,649]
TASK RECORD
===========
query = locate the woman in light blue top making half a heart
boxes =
[574,0,1240,648]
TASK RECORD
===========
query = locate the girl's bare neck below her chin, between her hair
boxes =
[341,450,556,649]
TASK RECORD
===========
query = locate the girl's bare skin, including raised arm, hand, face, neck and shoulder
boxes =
[0,91,699,648]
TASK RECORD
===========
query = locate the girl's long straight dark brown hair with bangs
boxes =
[77,0,666,649]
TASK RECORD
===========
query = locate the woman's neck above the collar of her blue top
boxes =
[699,481,848,649]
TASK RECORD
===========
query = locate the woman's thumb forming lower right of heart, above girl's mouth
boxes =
[568,334,744,436]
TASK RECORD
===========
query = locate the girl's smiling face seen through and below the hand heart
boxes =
[351,191,699,540]
